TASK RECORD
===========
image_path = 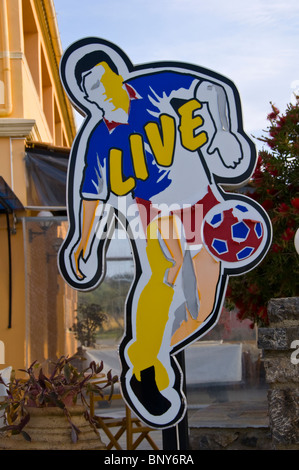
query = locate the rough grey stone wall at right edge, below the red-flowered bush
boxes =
[258,297,299,450]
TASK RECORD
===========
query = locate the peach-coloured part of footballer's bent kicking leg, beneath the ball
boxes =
[171,246,220,346]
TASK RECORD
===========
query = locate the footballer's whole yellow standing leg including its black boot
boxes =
[126,213,183,424]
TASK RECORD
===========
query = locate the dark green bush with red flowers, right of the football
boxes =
[226,96,299,325]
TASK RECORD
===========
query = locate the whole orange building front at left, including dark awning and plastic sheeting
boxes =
[0,0,76,369]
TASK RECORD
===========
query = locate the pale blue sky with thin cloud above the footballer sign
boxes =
[54,0,299,151]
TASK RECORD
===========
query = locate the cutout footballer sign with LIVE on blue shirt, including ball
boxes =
[59,38,271,428]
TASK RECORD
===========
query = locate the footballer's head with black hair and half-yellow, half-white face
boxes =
[75,51,128,111]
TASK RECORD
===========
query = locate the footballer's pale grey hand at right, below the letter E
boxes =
[208,130,243,168]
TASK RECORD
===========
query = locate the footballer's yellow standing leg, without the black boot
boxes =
[128,217,183,390]
